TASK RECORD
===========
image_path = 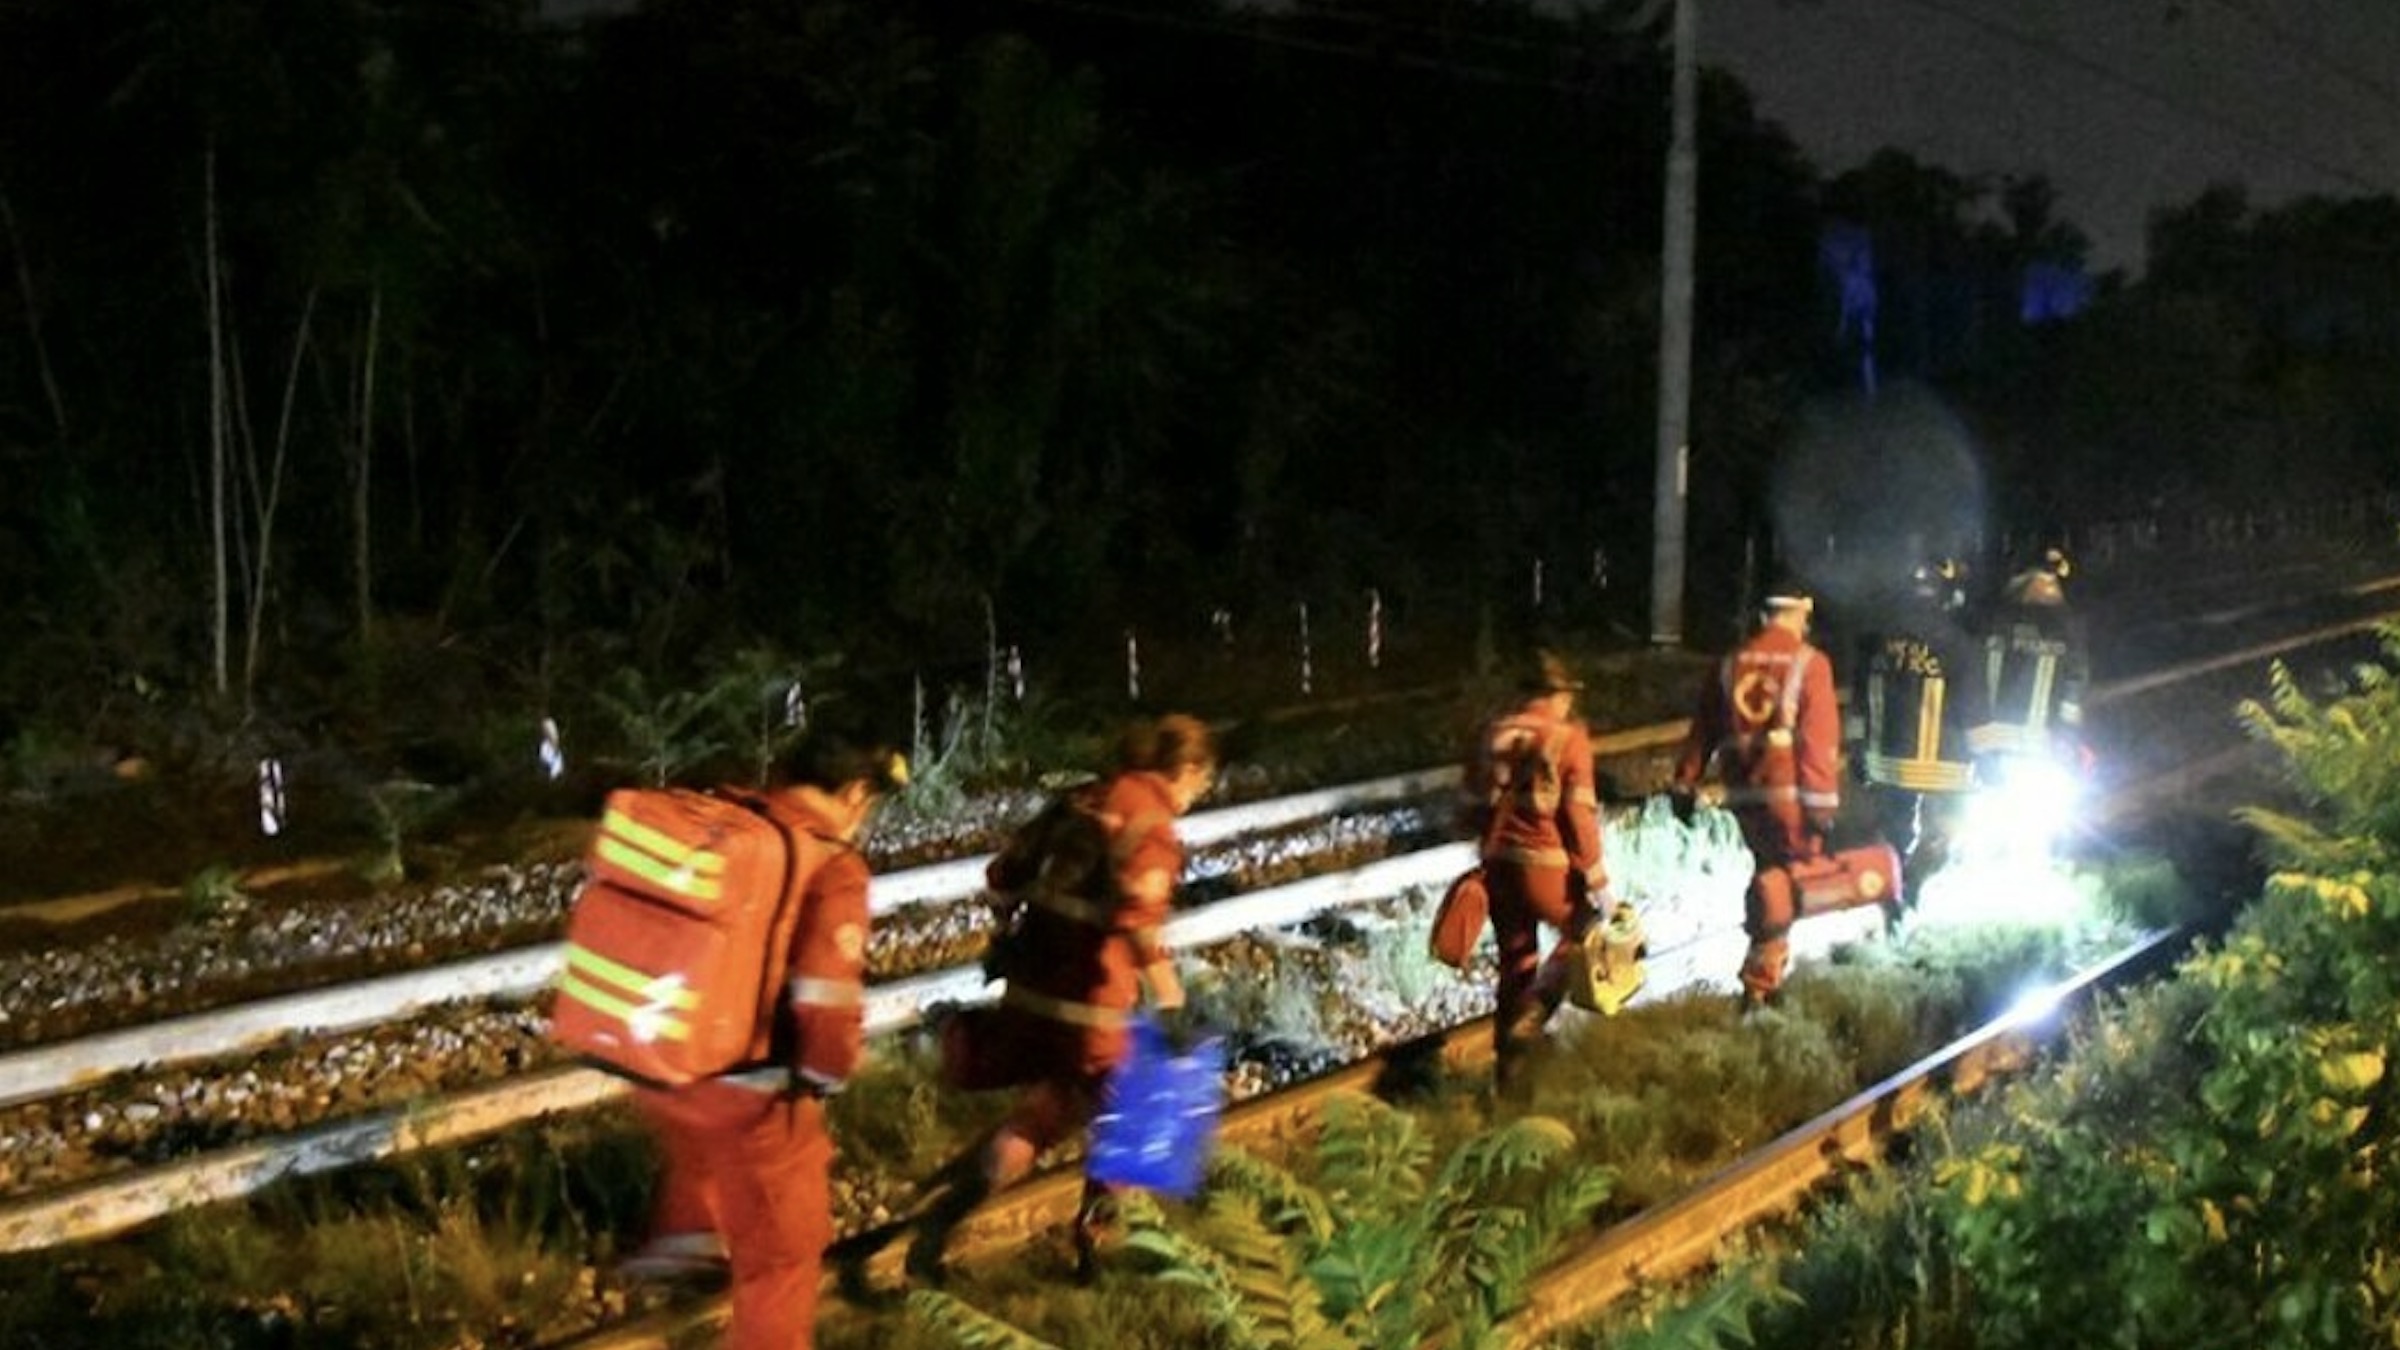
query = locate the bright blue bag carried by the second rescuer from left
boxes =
[1085,1014,1224,1196]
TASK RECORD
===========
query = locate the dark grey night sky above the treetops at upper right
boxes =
[1702,0,2400,269]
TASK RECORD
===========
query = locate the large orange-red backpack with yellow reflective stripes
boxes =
[550,788,816,1088]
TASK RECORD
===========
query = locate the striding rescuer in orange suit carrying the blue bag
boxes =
[907,713,1217,1283]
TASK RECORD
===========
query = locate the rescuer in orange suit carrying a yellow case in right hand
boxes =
[1466,651,1613,1086]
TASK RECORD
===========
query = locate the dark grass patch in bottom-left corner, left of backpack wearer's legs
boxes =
[0,1112,655,1350]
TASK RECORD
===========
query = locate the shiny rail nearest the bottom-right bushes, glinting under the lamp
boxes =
[1507,930,2189,1348]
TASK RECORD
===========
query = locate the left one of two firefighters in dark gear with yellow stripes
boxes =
[1846,557,1990,877]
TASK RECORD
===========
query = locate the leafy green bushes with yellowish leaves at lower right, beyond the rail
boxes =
[1577,627,2400,1350]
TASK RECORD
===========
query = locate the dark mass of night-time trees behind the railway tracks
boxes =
[0,0,2400,807]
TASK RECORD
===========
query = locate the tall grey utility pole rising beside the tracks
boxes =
[1651,0,1699,646]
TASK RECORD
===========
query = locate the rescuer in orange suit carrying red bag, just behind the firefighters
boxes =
[1673,584,1841,1011]
